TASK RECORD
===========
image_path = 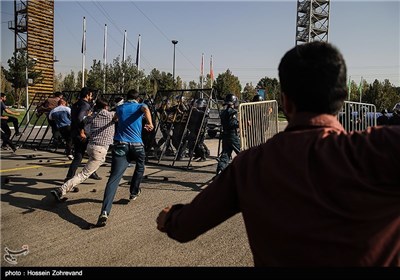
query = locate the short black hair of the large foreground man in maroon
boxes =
[279,42,347,115]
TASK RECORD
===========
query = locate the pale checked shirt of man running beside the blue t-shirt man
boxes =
[85,109,115,146]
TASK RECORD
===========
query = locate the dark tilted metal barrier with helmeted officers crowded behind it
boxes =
[148,89,220,169]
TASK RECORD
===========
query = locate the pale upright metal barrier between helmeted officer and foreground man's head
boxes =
[239,100,278,151]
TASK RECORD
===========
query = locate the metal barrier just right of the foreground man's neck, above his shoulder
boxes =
[338,101,377,132]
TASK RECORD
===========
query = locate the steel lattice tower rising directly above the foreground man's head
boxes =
[296,0,330,45]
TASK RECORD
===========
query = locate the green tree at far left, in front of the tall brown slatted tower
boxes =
[2,50,42,108]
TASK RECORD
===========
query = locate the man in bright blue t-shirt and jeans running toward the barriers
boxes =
[97,89,154,227]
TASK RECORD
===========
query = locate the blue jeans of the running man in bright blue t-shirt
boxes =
[101,143,146,215]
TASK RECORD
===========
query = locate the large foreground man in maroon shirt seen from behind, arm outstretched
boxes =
[157,42,400,266]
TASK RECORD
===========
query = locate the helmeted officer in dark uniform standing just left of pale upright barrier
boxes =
[217,93,240,174]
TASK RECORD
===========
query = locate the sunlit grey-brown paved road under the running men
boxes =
[1,122,288,267]
